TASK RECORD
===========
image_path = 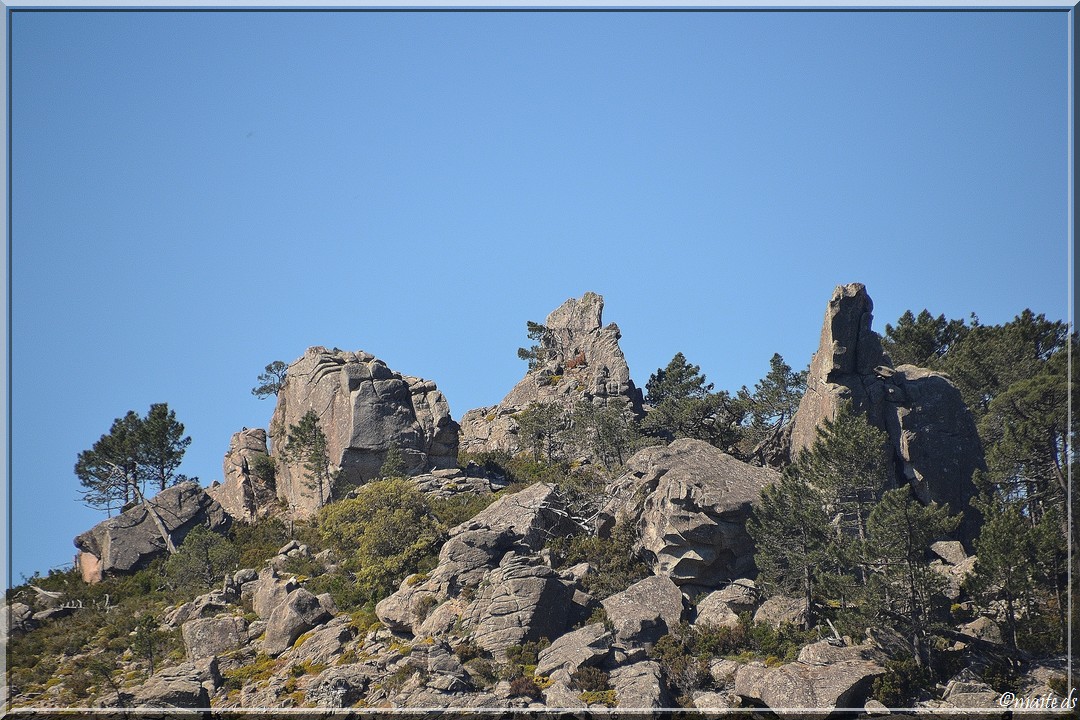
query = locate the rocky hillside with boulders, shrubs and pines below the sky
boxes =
[3,284,1075,718]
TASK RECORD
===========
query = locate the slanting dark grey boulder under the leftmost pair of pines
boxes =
[75,483,230,583]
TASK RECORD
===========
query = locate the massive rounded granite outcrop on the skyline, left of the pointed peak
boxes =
[270,348,458,517]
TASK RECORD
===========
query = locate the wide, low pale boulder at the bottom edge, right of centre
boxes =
[734,640,885,720]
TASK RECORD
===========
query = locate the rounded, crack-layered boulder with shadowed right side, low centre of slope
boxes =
[461,553,573,657]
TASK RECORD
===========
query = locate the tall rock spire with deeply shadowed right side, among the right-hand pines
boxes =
[791,283,985,540]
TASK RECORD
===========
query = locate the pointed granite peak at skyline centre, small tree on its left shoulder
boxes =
[461,293,642,453]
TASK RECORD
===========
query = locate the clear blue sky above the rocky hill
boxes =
[10,11,1069,583]
